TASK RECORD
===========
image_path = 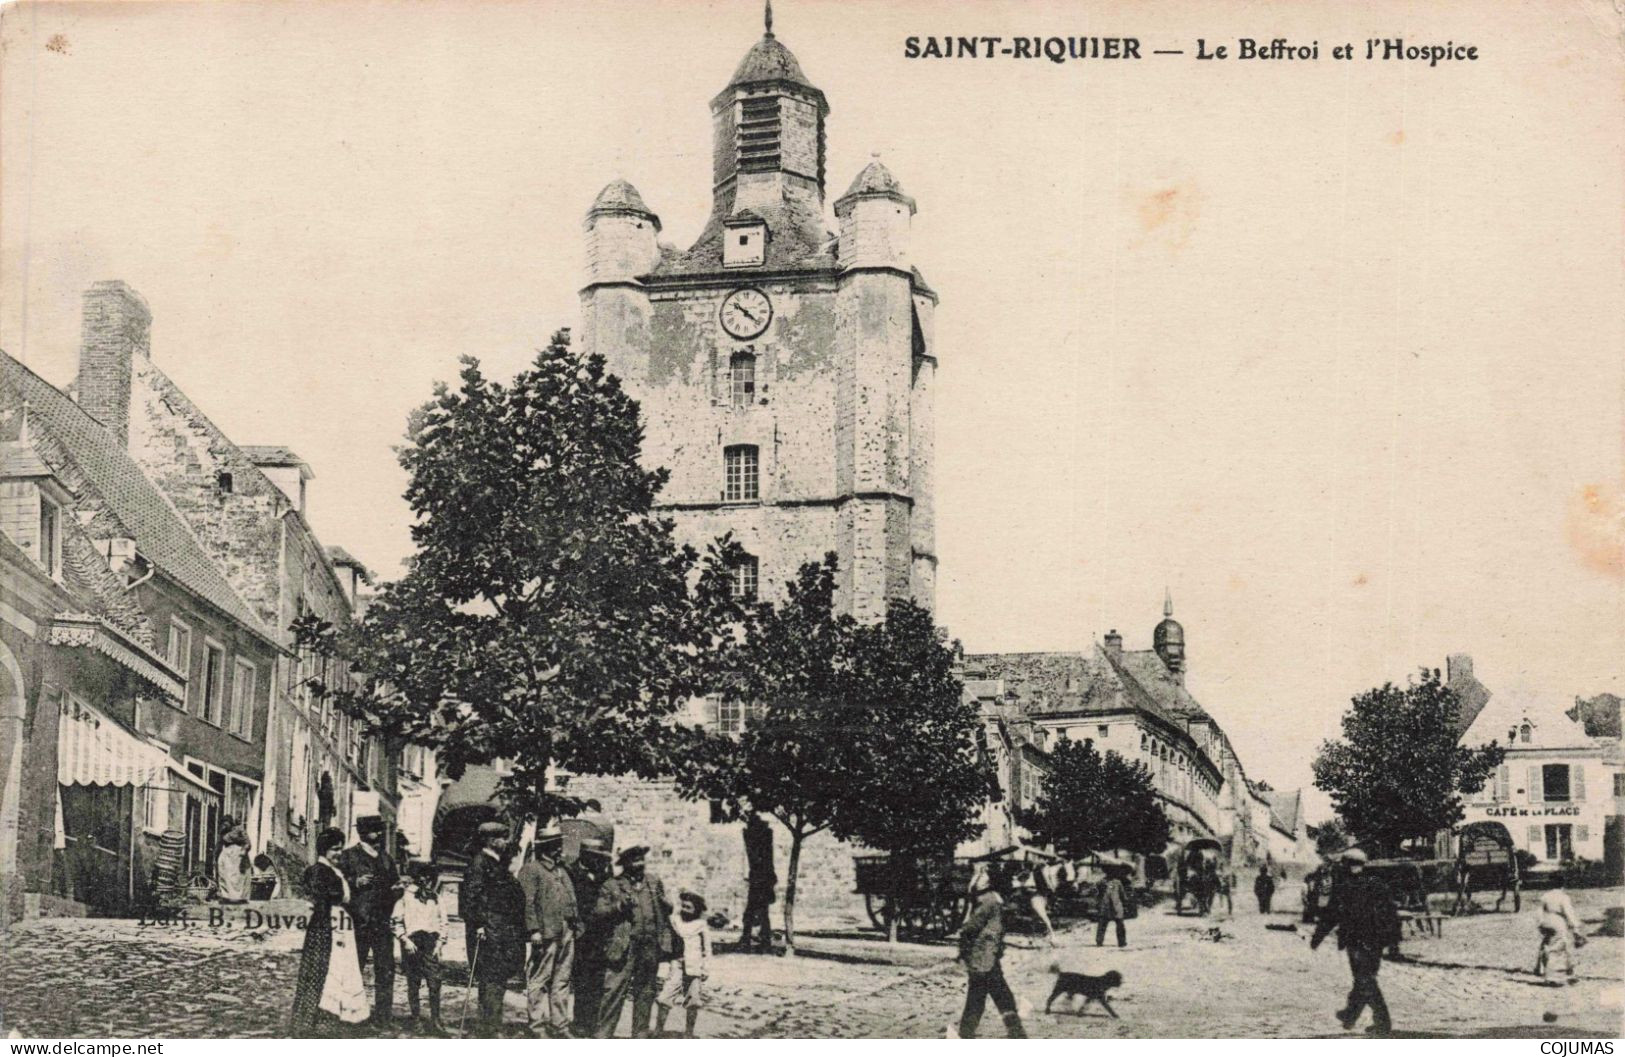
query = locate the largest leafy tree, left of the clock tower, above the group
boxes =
[296,330,739,818]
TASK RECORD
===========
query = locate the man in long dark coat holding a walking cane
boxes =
[457,823,525,1037]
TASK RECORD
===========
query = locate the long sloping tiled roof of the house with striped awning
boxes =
[0,351,276,642]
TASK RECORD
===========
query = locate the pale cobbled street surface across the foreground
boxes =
[0,890,1625,1037]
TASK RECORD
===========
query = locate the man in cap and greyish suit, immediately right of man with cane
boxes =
[518,826,582,1039]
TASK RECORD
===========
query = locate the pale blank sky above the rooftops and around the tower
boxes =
[0,0,1625,816]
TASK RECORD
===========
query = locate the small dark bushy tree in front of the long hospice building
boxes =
[1021,738,1168,855]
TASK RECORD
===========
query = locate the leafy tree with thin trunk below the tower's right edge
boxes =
[835,602,998,942]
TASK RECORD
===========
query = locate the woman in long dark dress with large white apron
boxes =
[288,828,367,1039]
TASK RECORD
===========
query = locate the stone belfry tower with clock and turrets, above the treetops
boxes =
[580,8,936,620]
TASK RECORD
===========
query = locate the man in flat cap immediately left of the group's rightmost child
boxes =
[593,846,671,1039]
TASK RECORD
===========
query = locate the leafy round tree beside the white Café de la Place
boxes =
[1315,668,1505,855]
